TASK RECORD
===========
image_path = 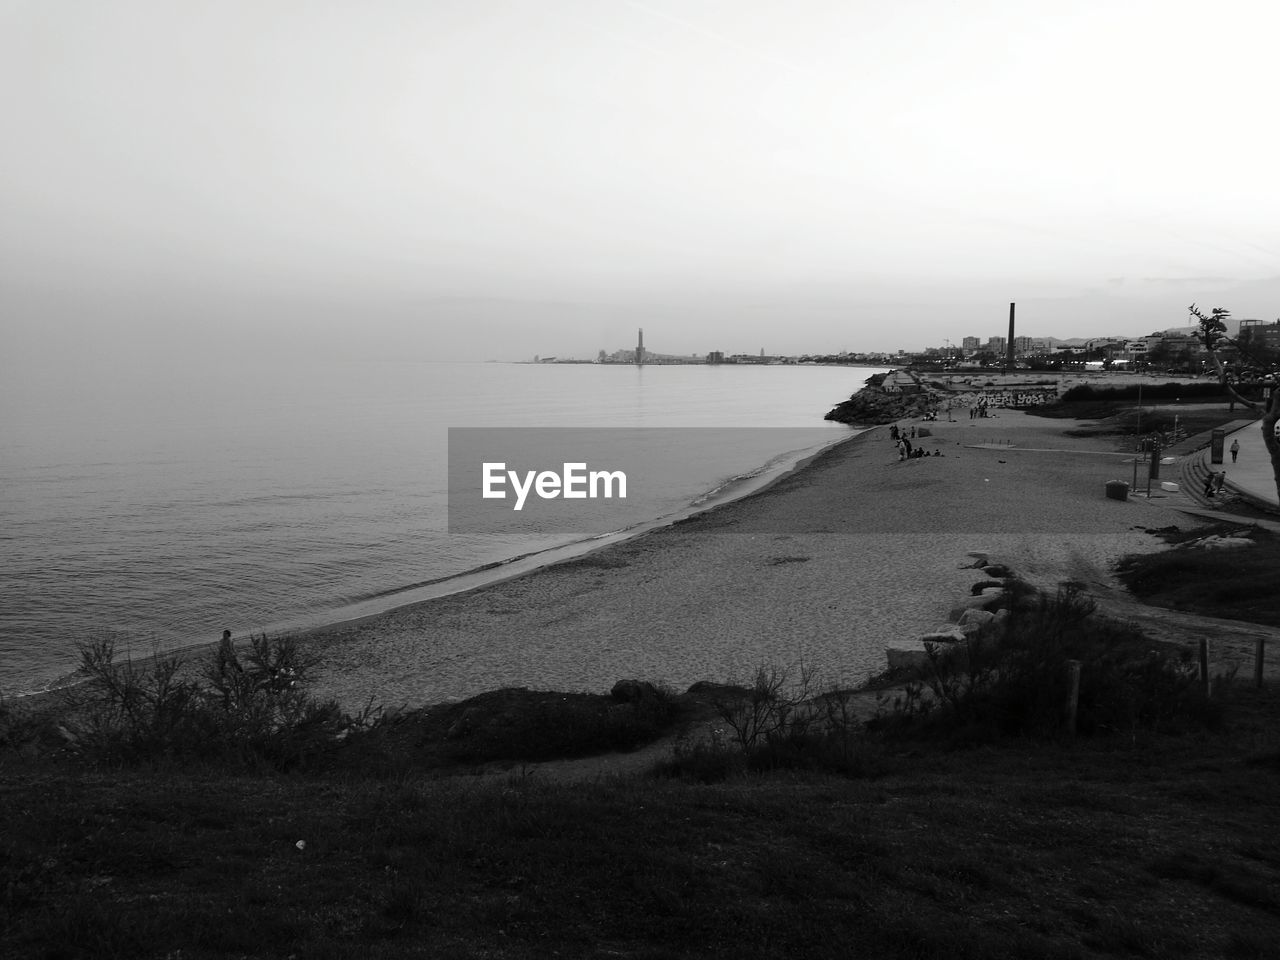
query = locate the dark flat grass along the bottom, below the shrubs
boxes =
[0,690,1280,960]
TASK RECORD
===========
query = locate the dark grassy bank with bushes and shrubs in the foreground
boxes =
[0,584,1280,960]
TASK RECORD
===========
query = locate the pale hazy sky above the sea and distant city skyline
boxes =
[0,0,1280,362]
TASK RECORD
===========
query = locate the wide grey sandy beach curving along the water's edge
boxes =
[306,411,1208,708]
